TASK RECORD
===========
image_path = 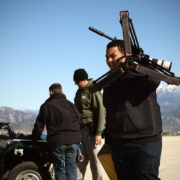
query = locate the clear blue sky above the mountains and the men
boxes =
[0,0,180,110]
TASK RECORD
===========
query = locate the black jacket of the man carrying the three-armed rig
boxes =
[103,72,162,143]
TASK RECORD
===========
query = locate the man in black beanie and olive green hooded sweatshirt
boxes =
[73,69,105,180]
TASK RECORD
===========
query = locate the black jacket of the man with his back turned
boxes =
[32,93,81,146]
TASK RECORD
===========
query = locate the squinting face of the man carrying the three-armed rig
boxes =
[106,47,125,69]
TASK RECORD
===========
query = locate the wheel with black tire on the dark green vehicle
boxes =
[7,161,52,180]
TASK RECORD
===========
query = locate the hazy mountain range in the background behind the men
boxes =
[0,83,180,133]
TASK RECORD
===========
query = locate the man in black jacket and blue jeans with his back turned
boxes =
[32,83,81,180]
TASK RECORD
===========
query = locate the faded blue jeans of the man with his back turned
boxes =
[52,144,77,180]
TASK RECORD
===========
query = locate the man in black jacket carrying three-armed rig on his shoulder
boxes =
[103,40,162,180]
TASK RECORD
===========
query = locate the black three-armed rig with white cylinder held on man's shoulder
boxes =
[89,11,180,93]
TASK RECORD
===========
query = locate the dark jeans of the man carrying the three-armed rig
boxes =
[112,139,162,180]
